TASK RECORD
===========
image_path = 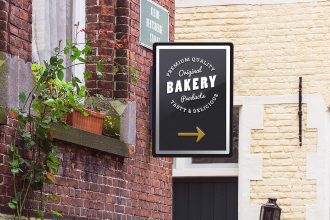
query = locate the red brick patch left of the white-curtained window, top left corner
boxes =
[0,0,32,61]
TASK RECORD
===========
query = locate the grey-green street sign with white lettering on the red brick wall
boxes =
[140,0,169,49]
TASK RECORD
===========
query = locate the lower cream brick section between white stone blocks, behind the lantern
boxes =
[250,104,317,220]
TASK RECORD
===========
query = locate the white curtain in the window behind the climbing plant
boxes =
[32,0,86,82]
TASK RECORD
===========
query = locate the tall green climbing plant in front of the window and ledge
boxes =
[8,40,96,220]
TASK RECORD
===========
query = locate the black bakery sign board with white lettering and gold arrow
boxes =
[153,43,233,157]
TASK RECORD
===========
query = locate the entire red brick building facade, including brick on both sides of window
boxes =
[0,0,174,220]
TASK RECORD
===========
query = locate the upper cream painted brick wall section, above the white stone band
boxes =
[175,1,330,106]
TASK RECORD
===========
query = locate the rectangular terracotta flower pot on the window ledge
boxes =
[68,109,105,135]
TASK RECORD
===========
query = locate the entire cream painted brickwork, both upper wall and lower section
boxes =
[175,1,324,220]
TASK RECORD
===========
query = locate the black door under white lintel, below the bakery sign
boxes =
[173,177,238,220]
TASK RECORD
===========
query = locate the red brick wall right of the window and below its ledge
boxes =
[0,0,174,220]
